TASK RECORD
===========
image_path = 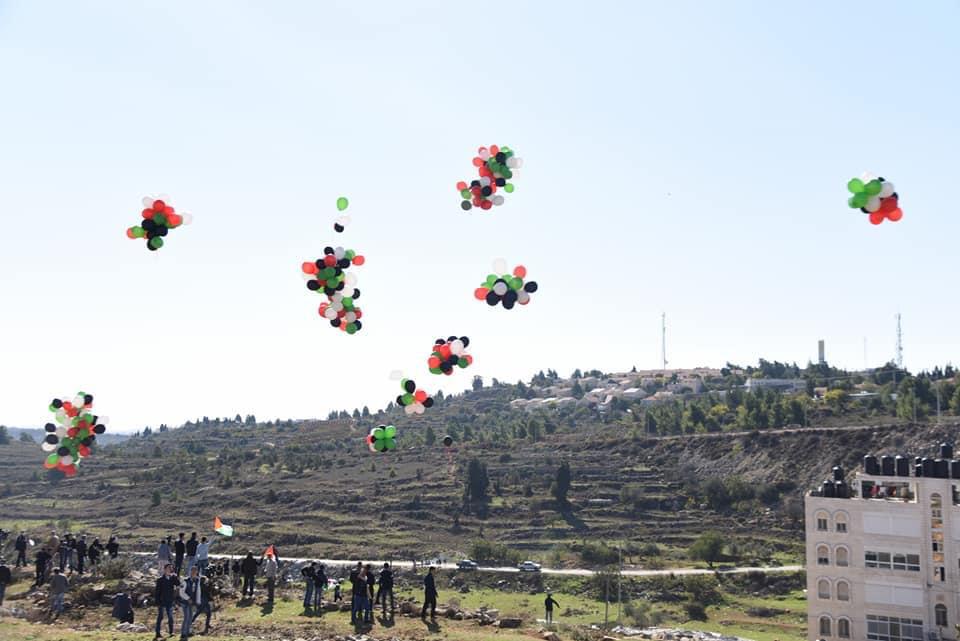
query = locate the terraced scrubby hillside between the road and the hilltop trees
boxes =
[0,372,958,566]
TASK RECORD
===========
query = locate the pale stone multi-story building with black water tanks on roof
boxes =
[805,444,960,641]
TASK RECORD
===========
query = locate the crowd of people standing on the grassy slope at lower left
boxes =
[0,530,464,640]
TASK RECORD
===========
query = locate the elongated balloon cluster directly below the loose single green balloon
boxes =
[301,247,365,334]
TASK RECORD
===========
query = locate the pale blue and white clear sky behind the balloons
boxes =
[0,0,960,430]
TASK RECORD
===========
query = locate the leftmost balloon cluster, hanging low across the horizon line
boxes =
[40,392,107,476]
